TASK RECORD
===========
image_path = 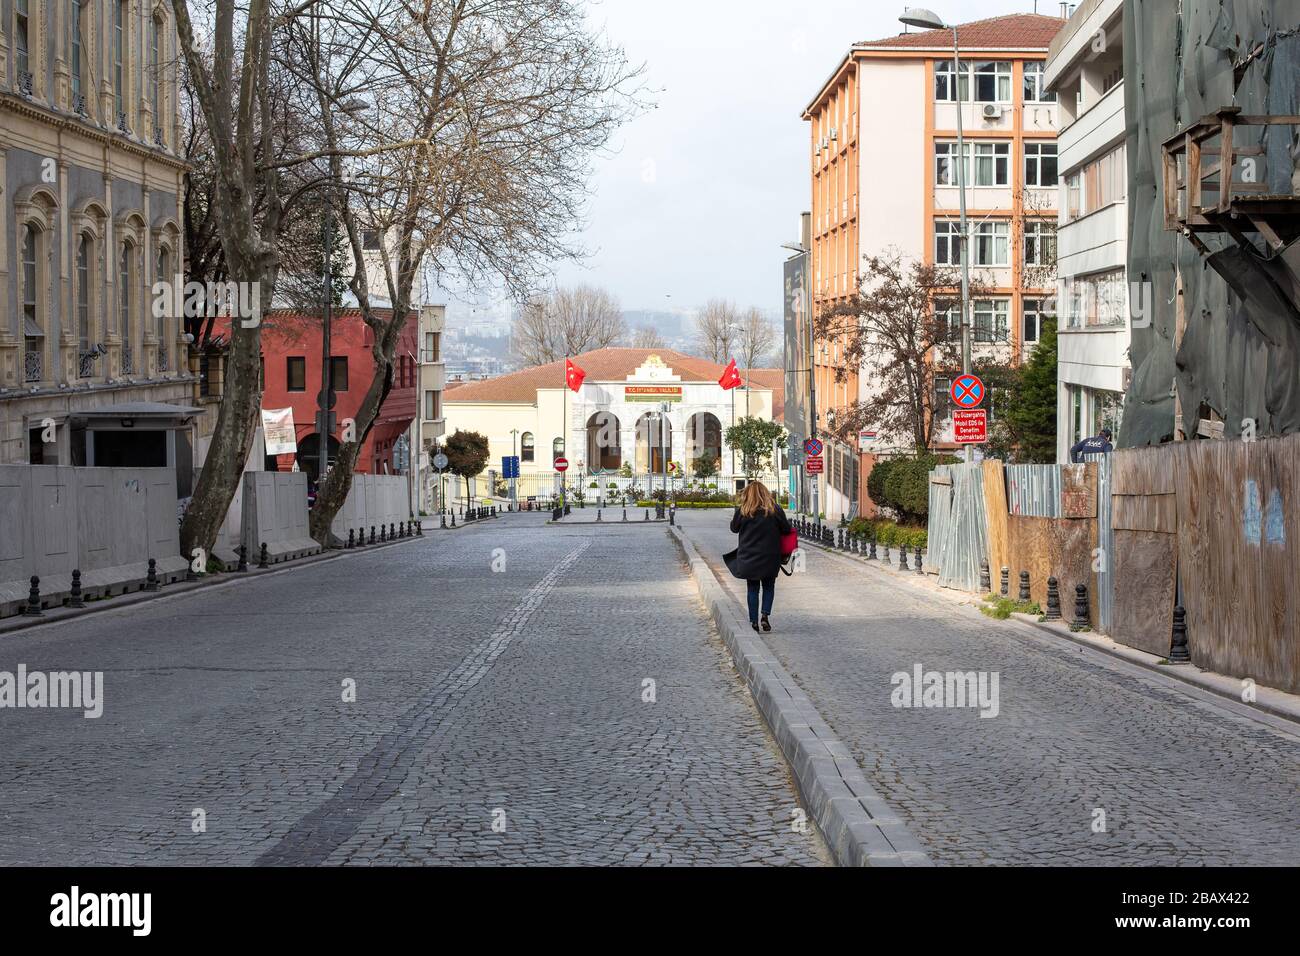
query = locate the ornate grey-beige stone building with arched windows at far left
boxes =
[0,0,198,481]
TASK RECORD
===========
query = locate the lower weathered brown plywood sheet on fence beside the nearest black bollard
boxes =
[1110,528,1178,657]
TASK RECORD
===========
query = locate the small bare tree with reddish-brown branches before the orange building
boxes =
[813,250,984,451]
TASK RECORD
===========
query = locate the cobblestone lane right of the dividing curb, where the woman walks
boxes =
[680,514,1300,865]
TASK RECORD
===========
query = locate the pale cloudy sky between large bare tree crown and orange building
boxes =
[543,0,1040,315]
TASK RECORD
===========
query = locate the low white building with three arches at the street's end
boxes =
[443,349,784,497]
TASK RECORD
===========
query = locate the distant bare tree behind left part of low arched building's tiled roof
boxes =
[511,285,628,365]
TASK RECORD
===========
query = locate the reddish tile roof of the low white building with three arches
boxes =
[443,347,784,405]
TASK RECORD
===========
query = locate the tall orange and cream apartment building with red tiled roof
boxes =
[803,14,1065,518]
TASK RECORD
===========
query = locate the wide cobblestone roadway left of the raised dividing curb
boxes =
[0,515,829,865]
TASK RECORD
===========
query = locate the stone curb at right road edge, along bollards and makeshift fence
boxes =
[800,538,1300,723]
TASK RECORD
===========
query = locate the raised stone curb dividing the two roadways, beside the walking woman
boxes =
[671,528,932,866]
